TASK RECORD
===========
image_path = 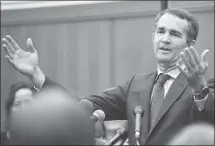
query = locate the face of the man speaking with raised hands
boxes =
[153,13,188,67]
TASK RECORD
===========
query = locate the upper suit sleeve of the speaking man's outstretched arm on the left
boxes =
[86,76,134,120]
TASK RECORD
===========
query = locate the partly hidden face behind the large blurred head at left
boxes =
[12,88,32,111]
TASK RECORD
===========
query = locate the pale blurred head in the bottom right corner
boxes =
[168,123,214,145]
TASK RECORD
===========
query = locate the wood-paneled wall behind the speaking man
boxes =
[1,1,214,131]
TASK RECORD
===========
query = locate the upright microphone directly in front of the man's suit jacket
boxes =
[134,106,144,140]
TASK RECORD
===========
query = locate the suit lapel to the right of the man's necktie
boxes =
[148,73,188,136]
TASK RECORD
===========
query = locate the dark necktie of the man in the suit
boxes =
[150,73,170,127]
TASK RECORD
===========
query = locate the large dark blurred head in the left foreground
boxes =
[10,87,94,145]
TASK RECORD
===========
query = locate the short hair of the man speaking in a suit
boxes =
[155,8,199,43]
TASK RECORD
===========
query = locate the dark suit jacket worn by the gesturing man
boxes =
[44,73,214,145]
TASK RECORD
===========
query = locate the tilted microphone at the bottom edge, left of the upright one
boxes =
[106,127,128,145]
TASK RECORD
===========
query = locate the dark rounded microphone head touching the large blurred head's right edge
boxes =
[79,99,93,117]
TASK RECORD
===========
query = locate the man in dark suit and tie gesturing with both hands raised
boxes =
[2,9,214,145]
